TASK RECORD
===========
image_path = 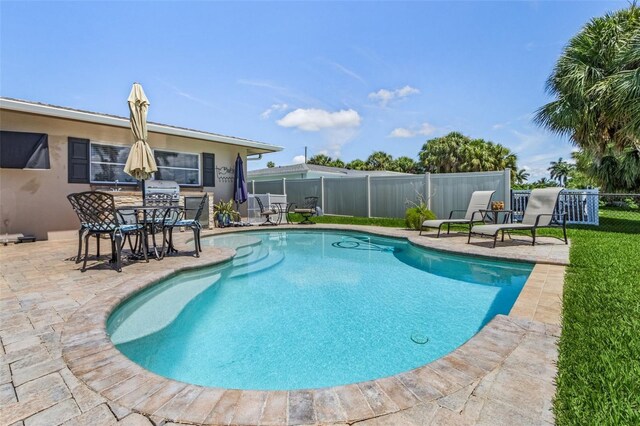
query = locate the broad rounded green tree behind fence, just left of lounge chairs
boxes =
[418,132,517,179]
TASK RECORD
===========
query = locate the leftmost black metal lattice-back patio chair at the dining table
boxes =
[69,191,149,272]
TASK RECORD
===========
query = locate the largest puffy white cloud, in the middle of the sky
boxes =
[276,108,362,132]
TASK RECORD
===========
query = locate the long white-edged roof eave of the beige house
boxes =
[0,97,282,154]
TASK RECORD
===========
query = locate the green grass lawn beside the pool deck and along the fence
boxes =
[298,209,640,425]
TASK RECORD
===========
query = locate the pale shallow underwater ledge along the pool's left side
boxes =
[111,269,222,345]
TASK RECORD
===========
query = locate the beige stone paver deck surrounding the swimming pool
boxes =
[0,225,568,426]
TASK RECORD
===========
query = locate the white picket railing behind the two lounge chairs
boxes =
[511,189,599,225]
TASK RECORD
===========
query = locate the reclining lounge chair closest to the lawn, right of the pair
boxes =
[467,188,568,247]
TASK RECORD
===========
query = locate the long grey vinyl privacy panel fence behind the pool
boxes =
[249,169,511,218]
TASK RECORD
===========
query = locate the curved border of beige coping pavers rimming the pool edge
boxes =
[61,227,560,425]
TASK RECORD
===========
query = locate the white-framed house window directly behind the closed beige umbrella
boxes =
[90,142,137,183]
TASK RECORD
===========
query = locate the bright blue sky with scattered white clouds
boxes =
[0,1,627,178]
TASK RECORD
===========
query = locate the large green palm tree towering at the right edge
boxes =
[535,3,640,191]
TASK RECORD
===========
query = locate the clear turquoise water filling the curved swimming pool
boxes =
[107,231,532,390]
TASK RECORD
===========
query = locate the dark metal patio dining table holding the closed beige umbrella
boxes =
[116,204,184,260]
